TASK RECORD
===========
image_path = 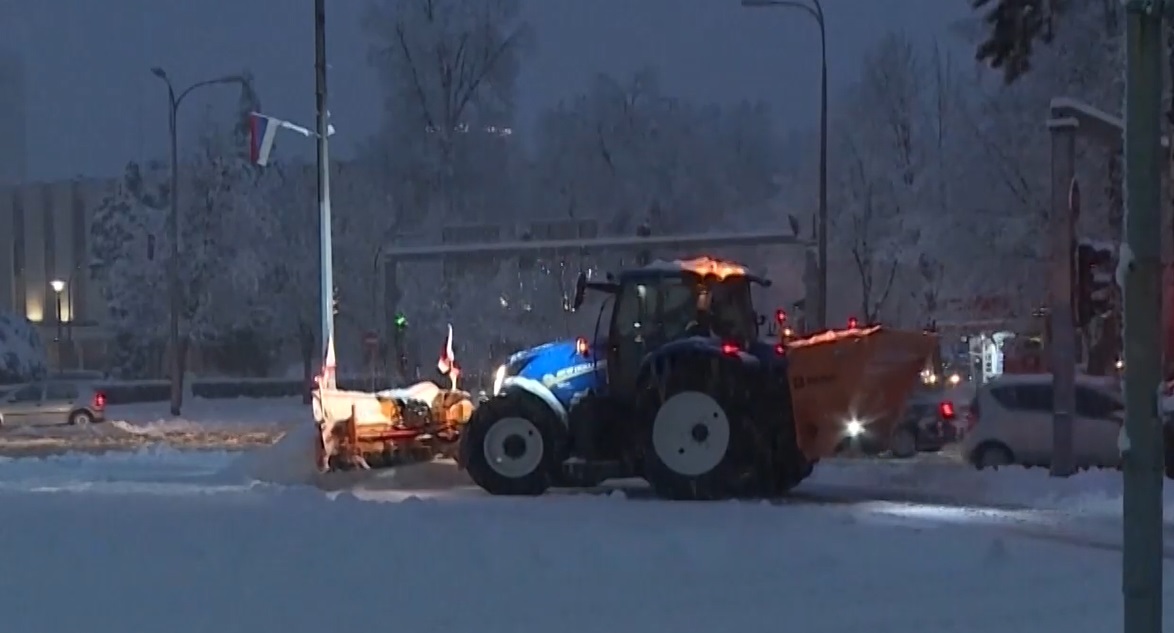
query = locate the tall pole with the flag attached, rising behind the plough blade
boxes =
[313,0,335,357]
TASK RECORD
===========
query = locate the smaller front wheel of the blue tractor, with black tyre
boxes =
[459,391,567,496]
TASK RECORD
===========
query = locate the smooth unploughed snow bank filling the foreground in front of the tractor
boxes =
[0,479,1145,633]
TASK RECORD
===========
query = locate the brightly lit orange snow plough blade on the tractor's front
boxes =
[313,382,474,472]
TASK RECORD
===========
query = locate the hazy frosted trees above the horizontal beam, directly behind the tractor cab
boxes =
[533,69,781,234]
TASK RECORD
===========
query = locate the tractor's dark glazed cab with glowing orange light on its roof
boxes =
[575,257,770,398]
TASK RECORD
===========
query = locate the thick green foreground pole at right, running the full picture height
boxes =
[1118,0,1167,633]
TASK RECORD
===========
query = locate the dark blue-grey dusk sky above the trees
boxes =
[0,0,971,180]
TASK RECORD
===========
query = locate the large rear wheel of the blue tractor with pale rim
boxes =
[636,356,755,500]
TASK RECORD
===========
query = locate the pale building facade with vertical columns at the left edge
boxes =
[0,180,112,369]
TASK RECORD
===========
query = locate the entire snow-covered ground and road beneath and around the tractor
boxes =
[0,400,1174,633]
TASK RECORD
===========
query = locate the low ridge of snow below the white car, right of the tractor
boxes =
[805,459,1174,517]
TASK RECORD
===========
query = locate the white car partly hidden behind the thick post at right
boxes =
[962,373,1125,469]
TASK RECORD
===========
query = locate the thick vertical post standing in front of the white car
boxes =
[1047,119,1080,477]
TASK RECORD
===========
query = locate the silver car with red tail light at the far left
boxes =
[0,379,106,426]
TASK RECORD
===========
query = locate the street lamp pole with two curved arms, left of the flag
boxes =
[150,66,249,416]
